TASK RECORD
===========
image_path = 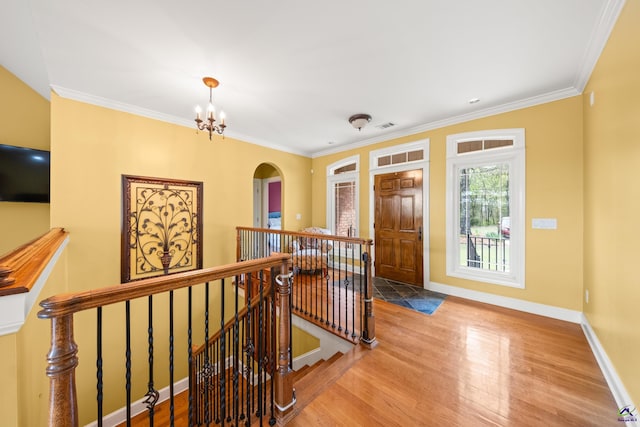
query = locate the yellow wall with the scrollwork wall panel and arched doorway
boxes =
[46,95,311,423]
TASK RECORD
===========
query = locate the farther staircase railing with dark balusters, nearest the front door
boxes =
[236,227,377,346]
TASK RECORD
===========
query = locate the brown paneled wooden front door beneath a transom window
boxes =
[374,170,423,287]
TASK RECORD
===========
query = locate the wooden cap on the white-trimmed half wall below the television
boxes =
[0,228,68,296]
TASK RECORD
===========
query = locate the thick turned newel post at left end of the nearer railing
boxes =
[47,314,78,427]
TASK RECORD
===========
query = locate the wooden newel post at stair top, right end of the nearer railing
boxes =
[275,261,296,415]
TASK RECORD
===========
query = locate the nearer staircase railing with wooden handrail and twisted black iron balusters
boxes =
[38,255,294,426]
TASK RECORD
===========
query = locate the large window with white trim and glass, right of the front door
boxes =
[446,129,525,288]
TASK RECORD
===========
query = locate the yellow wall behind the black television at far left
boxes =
[0,66,50,256]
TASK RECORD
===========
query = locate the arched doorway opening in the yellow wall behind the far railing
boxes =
[253,163,283,229]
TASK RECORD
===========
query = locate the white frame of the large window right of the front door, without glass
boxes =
[446,129,526,289]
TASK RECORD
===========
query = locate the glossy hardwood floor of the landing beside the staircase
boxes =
[122,297,621,427]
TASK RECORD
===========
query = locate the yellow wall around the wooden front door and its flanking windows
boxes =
[312,97,583,310]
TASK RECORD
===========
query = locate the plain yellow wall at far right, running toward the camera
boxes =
[583,1,640,404]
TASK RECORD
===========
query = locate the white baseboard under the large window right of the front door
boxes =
[426,282,582,324]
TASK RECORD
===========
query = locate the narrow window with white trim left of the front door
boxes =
[327,156,360,237]
